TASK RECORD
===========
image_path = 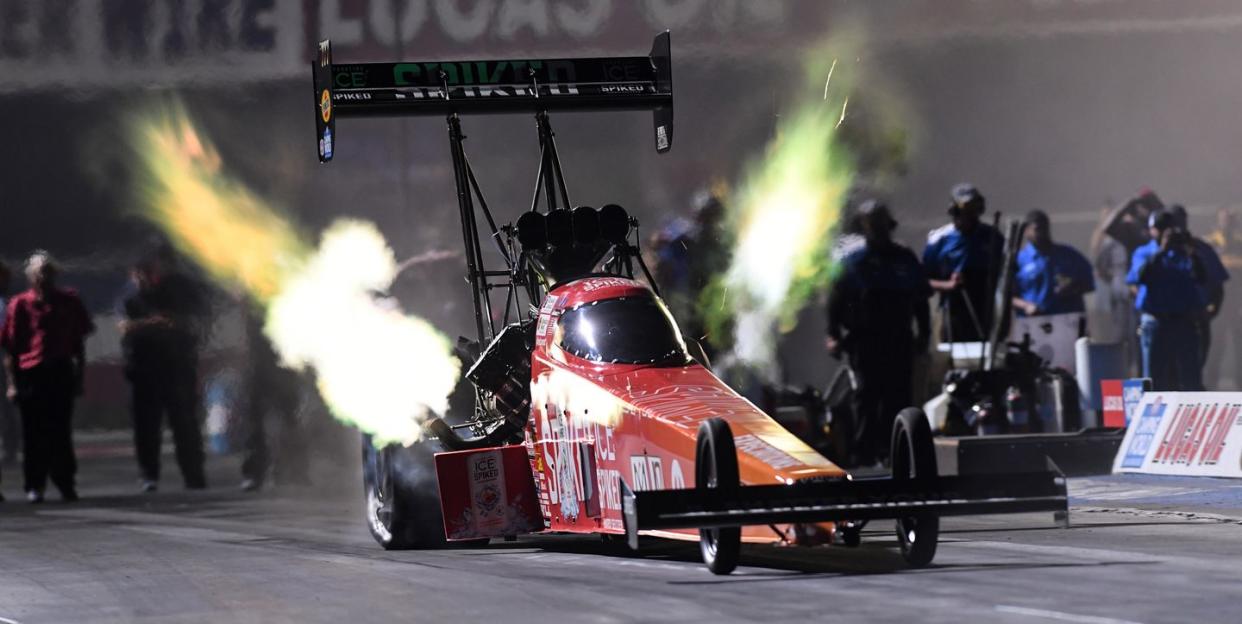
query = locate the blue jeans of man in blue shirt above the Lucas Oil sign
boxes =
[1139,313,1203,392]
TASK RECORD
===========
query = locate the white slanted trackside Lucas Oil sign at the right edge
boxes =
[1113,393,1242,477]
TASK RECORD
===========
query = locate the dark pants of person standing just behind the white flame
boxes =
[241,369,308,484]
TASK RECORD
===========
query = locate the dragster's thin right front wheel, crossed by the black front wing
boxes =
[892,408,940,568]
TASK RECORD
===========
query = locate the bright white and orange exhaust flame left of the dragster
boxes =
[134,107,460,445]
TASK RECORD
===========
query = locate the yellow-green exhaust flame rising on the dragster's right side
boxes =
[704,61,853,370]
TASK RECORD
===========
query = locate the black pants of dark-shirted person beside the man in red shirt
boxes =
[129,363,206,487]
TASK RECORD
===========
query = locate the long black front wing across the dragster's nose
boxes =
[621,461,1069,548]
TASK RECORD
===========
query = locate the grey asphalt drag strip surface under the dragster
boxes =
[0,445,1242,624]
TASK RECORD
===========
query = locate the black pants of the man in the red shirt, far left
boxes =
[17,362,77,492]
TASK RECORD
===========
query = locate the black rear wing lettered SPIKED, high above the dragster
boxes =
[311,31,673,163]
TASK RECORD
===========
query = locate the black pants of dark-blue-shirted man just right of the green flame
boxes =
[850,337,914,465]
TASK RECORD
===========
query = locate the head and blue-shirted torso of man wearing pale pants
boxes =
[1013,210,1095,316]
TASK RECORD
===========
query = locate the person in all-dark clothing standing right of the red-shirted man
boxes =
[120,245,209,492]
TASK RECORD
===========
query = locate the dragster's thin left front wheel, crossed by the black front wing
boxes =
[694,418,741,574]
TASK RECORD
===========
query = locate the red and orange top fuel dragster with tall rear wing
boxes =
[312,32,1067,574]
